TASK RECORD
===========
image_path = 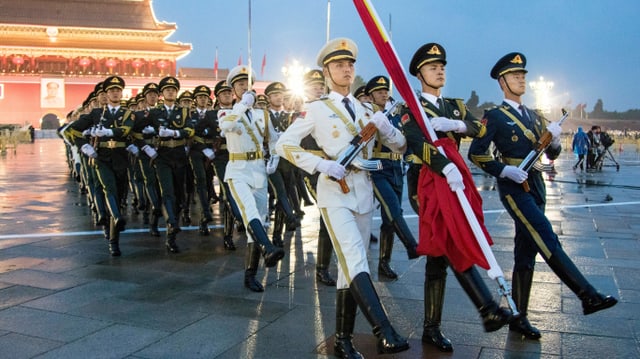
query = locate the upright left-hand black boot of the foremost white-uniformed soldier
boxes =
[333,288,364,359]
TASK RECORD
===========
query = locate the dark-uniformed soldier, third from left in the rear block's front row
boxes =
[189,85,217,236]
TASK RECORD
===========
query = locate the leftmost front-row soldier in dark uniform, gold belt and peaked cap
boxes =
[71,76,135,257]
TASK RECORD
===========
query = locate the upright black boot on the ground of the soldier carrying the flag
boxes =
[422,277,453,352]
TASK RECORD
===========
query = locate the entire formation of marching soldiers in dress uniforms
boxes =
[60,38,617,358]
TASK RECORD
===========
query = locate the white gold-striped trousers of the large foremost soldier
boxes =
[320,208,373,289]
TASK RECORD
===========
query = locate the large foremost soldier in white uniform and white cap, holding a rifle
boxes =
[276,38,409,358]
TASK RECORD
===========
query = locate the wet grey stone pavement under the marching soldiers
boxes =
[0,139,640,359]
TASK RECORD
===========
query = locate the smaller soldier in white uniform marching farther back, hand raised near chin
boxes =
[219,65,284,292]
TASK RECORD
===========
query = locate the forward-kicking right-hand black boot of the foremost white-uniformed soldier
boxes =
[349,272,409,354]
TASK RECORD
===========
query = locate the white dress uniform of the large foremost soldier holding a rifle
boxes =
[276,92,406,289]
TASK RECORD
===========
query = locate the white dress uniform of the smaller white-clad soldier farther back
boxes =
[219,103,278,241]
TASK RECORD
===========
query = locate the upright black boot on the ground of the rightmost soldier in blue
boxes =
[509,270,542,340]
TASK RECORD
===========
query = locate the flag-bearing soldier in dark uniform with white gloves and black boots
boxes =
[403,43,511,352]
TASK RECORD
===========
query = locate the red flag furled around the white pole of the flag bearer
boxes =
[353,0,492,276]
